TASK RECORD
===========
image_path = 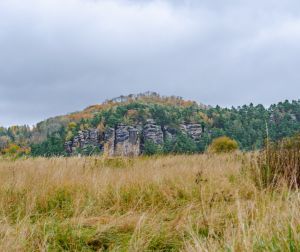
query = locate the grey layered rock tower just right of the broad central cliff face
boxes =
[143,119,164,145]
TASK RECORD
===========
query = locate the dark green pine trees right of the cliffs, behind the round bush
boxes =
[207,100,300,150]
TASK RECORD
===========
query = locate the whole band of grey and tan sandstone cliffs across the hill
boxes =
[65,119,202,156]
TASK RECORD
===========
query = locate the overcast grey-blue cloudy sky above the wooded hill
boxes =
[0,0,300,126]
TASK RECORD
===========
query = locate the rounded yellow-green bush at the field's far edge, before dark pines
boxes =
[208,136,239,153]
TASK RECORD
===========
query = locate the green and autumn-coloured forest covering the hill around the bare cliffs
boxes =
[0,94,300,156]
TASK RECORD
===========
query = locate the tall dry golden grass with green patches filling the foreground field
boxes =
[0,155,300,251]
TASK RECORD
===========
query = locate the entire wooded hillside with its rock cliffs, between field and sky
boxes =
[0,92,300,156]
